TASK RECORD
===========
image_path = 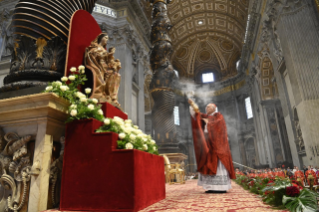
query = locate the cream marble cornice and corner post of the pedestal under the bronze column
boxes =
[0,93,69,211]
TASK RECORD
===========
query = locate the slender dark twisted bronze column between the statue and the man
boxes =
[150,0,178,153]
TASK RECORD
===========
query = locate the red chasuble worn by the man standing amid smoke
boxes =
[192,112,236,179]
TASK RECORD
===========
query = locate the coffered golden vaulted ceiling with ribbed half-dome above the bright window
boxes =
[168,0,248,80]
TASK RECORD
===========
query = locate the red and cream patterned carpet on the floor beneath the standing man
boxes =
[41,180,284,212]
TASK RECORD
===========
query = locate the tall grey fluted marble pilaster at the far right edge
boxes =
[276,1,319,165]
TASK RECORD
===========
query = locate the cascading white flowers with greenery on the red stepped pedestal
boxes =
[44,66,158,155]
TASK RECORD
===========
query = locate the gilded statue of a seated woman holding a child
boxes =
[85,33,122,107]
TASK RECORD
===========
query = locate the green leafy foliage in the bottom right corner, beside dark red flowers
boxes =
[282,189,318,212]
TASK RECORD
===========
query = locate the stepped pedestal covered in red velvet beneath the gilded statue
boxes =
[60,119,165,212]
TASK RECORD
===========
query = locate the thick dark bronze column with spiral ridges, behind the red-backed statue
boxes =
[0,0,97,93]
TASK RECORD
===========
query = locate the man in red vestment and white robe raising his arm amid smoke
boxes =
[188,99,236,193]
